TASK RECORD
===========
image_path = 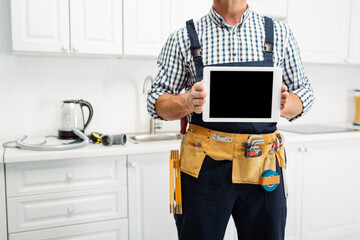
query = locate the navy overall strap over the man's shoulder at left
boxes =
[186,19,204,82]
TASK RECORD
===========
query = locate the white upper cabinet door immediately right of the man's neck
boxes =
[248,0,287,19]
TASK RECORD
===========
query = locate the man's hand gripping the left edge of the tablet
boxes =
[186,81,207,114]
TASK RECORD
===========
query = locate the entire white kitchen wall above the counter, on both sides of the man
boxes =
[0,0,360,140]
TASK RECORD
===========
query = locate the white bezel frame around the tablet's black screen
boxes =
[202,66,282,122]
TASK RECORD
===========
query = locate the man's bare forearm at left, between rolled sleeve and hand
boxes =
[155,93,193,120]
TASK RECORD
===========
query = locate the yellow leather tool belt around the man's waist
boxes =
[180,124,285,185]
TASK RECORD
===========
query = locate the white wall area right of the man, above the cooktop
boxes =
[280,64,360,124]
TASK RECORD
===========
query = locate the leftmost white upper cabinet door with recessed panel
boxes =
[11,0,69,52]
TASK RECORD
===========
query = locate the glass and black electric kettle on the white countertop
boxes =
[58,99,94,139]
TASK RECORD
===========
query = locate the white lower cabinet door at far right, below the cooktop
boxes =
[301,140,360,240]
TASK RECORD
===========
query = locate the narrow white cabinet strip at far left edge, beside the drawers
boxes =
[0,162,7,240]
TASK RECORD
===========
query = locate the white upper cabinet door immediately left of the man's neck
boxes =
[171,0,213,32]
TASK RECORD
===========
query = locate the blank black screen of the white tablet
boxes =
[209,71,273,118]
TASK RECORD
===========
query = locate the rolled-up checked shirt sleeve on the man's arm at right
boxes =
[283,28,315,121]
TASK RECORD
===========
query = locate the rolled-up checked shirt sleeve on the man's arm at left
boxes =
[147,33,186,119]
